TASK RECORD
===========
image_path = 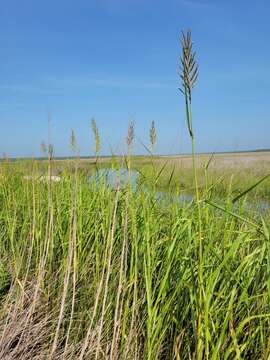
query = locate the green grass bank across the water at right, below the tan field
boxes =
[134,159,270,201]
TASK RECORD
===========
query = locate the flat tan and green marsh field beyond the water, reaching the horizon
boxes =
[51,151,270,201]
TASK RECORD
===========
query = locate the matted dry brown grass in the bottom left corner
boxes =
[0,284,78,360]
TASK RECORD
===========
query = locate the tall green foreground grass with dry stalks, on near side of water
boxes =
[0,161,270,359]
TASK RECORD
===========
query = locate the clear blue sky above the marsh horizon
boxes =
[0,0,270,156]
